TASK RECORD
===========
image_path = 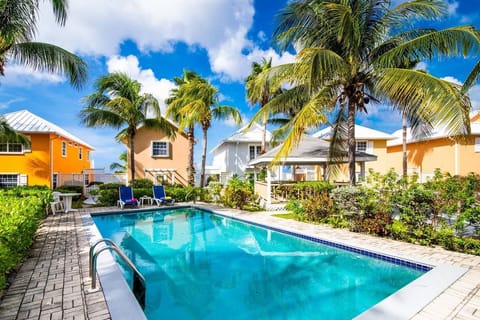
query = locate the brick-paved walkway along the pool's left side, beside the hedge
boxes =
[0,212,110,320]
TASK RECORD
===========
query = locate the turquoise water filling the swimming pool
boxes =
[93,208,424,320]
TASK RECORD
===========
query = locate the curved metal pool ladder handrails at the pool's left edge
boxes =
[89,238,146,309]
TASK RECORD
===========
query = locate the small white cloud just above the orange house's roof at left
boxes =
[2,64,66,86]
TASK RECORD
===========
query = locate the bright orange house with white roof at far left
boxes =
[0,110,94,188]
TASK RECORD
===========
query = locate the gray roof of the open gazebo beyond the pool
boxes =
[249,135,377,166]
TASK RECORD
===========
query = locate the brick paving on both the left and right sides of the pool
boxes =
[0,207,480,320]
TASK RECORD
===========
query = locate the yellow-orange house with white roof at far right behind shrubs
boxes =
[387,113,480,181]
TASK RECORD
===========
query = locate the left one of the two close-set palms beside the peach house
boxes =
[165,70,200,186]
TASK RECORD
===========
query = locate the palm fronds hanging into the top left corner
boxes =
[0,0,87,89]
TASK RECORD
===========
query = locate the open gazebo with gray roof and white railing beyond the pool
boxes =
[249,135,377,210]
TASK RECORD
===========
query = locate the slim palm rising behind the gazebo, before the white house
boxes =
[245,58,278,154]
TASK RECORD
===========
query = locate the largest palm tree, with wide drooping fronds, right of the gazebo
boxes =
[248,0,480,185]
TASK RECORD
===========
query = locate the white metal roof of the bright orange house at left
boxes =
[1,110,94,150]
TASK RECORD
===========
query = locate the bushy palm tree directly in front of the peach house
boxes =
[80,72,176,185]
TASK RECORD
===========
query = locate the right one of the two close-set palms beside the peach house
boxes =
[173,78,242,187]
